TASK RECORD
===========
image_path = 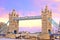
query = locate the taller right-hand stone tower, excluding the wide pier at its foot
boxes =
[42,6,52,33]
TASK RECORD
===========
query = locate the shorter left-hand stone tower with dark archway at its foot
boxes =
[9,9,19,33]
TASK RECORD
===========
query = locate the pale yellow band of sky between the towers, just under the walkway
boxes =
[19,20,41,28]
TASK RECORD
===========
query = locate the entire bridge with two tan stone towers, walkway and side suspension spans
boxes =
[0,6,59,38]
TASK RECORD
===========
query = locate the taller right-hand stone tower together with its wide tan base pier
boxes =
[40,6,52,39]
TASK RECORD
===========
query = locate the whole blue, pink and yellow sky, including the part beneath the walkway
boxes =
[0,0,60,32]
